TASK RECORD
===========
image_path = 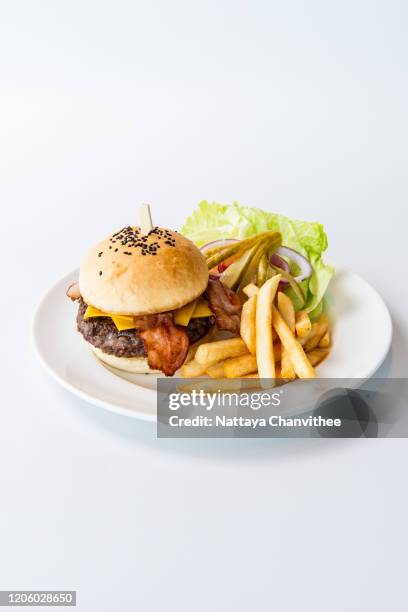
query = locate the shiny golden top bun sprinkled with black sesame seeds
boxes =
[79,227,208,315]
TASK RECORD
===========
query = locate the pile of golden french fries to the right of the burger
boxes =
[180,274,331,381]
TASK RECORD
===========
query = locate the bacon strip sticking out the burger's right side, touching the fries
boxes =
[207,276,242,334]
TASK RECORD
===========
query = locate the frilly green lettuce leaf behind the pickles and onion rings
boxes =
[181,201,334,314]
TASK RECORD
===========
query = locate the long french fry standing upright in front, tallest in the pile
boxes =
[256,274,281,379]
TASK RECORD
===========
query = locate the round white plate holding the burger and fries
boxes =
[33,270,392,420]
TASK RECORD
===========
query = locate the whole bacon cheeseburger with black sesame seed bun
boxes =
[67,227,241,376]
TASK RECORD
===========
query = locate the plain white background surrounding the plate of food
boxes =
[0,0,408,612]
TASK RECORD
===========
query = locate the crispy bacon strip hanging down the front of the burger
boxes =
[135,313,190,376]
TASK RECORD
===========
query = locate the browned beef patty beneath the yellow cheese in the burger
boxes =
[77,299,214,357]
